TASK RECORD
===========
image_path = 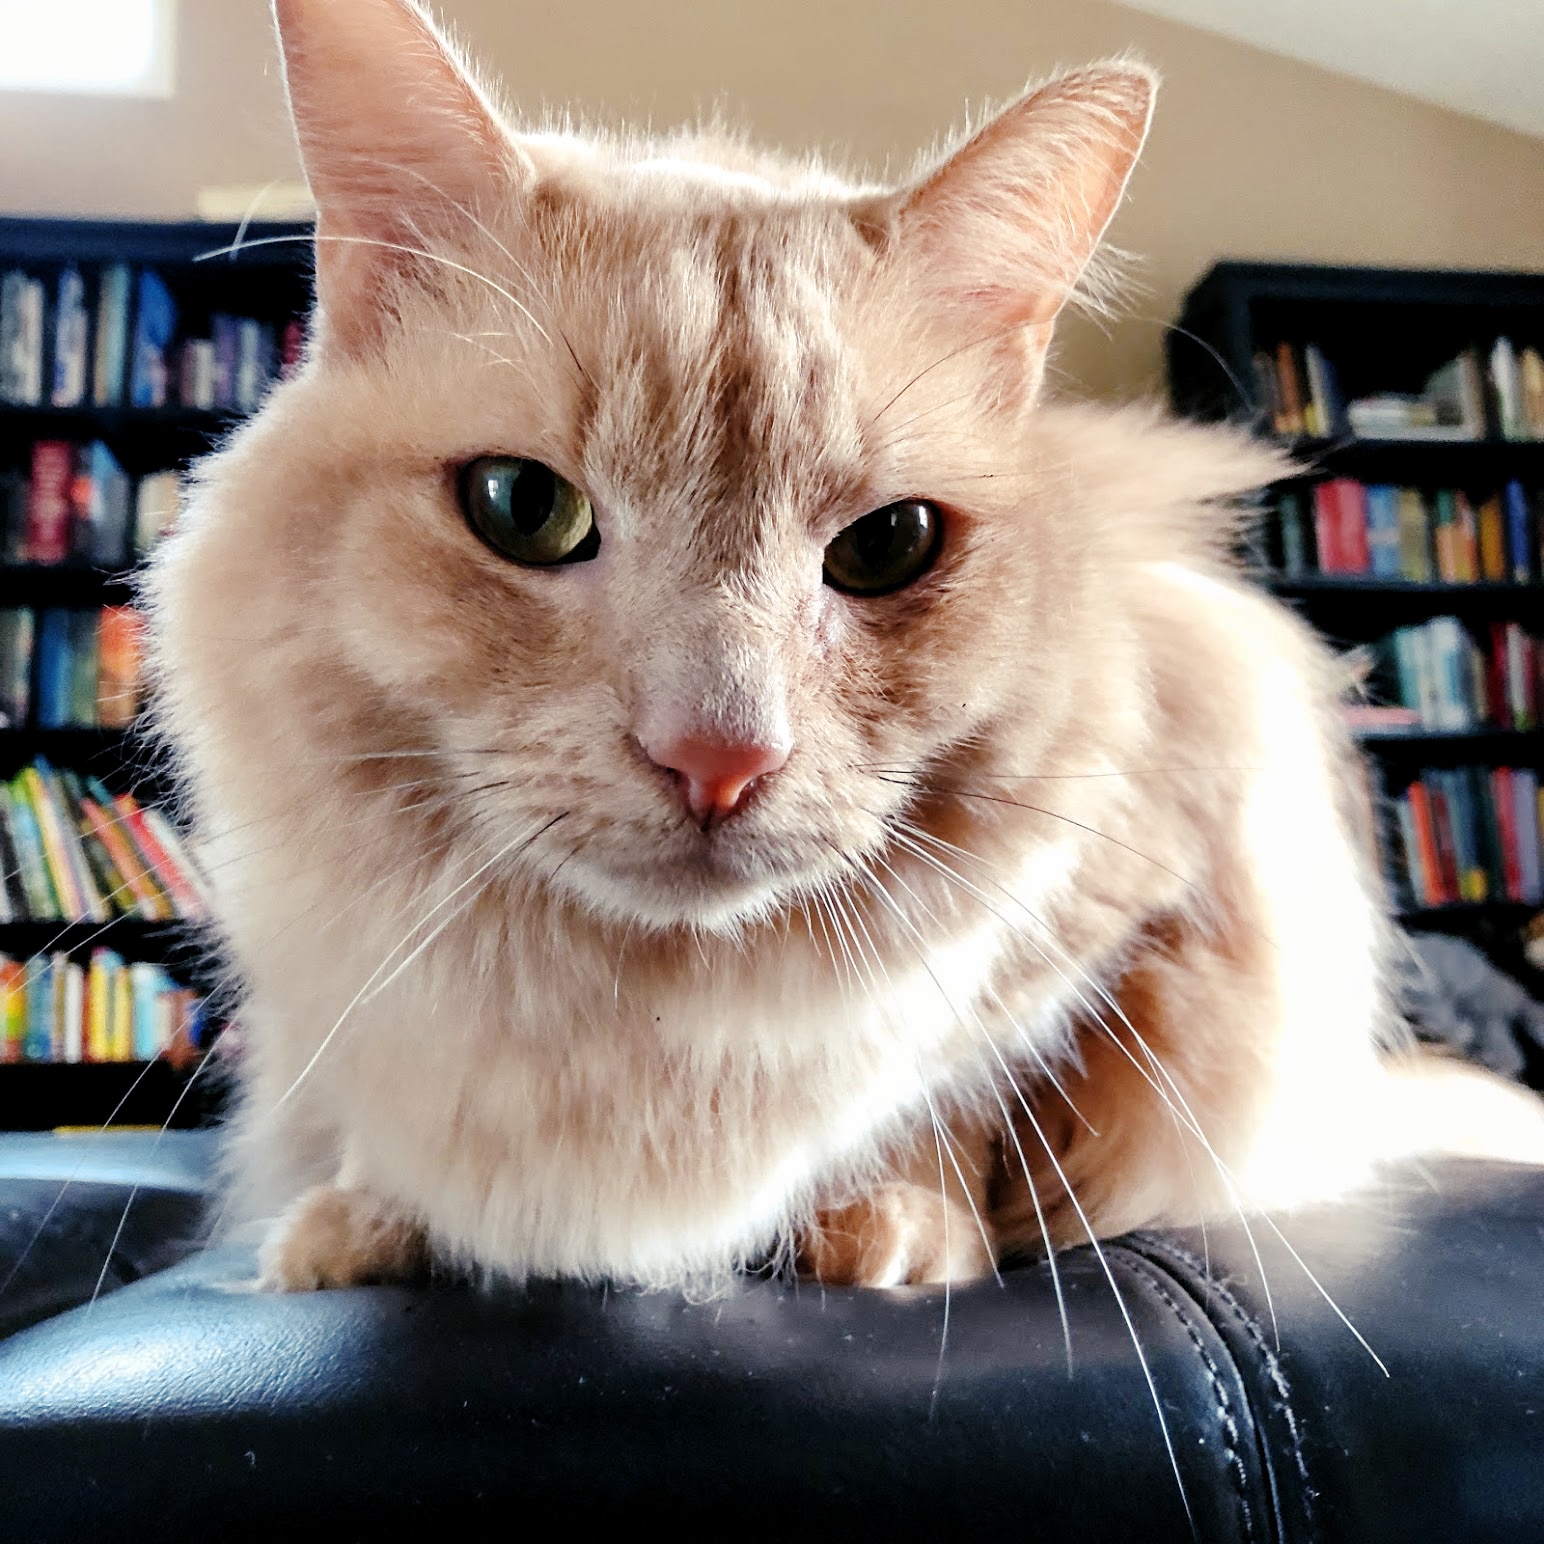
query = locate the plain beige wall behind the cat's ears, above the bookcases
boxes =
[0,0,1544,392]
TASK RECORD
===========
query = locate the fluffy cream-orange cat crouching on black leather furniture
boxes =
[147,0,1544,1291]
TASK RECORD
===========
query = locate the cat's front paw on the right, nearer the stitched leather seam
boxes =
[798,1181,997,1286]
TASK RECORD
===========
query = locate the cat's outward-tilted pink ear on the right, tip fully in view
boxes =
[857,62,1158,343]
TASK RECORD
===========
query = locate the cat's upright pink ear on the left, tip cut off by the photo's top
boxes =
[273,0,530,352]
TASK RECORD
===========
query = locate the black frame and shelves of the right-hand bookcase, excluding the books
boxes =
[1166,262,1544,974]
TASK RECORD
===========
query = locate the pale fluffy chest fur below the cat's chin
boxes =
[234,883,1031,1282]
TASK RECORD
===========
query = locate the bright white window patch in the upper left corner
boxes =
[0,0,176,97]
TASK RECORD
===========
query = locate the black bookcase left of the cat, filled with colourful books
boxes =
[0,219,309,1129]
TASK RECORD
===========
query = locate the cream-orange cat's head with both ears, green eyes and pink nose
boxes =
[162,0,1153,929]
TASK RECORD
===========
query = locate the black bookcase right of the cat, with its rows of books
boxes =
[1167,262,1544,991]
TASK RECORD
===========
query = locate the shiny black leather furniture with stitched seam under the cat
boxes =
[0,1135,1544,1544]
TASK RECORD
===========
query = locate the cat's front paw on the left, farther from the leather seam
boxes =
[258,1184,429,1292]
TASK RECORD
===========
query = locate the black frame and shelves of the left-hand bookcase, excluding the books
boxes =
[0,218,310,1130]
